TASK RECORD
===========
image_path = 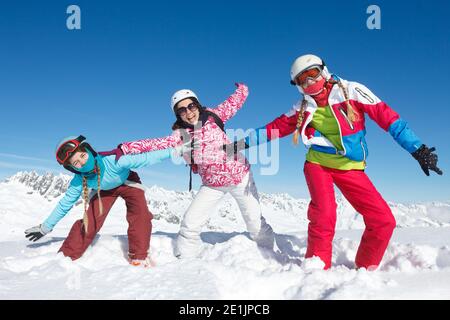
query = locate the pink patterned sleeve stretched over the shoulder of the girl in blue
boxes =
[120,130,181,154]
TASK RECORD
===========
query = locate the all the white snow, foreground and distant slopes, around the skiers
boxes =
[0,172,450,300]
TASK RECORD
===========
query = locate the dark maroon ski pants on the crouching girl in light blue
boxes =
[59,181,153,260]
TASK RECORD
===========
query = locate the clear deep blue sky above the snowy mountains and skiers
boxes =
[0,0,450,202]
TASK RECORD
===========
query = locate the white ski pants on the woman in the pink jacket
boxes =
[175,172,274,258]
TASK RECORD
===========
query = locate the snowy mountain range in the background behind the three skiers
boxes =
[4,171,450,230]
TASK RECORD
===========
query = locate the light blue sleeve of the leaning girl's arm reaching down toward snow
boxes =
[43,175,83,230]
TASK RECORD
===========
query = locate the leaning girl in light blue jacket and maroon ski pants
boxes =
[25,135,190,267]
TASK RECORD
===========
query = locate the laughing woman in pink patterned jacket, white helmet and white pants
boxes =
[121,84,274,258]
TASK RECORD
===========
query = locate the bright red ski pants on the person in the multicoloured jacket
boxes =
[304,162,395,269]
